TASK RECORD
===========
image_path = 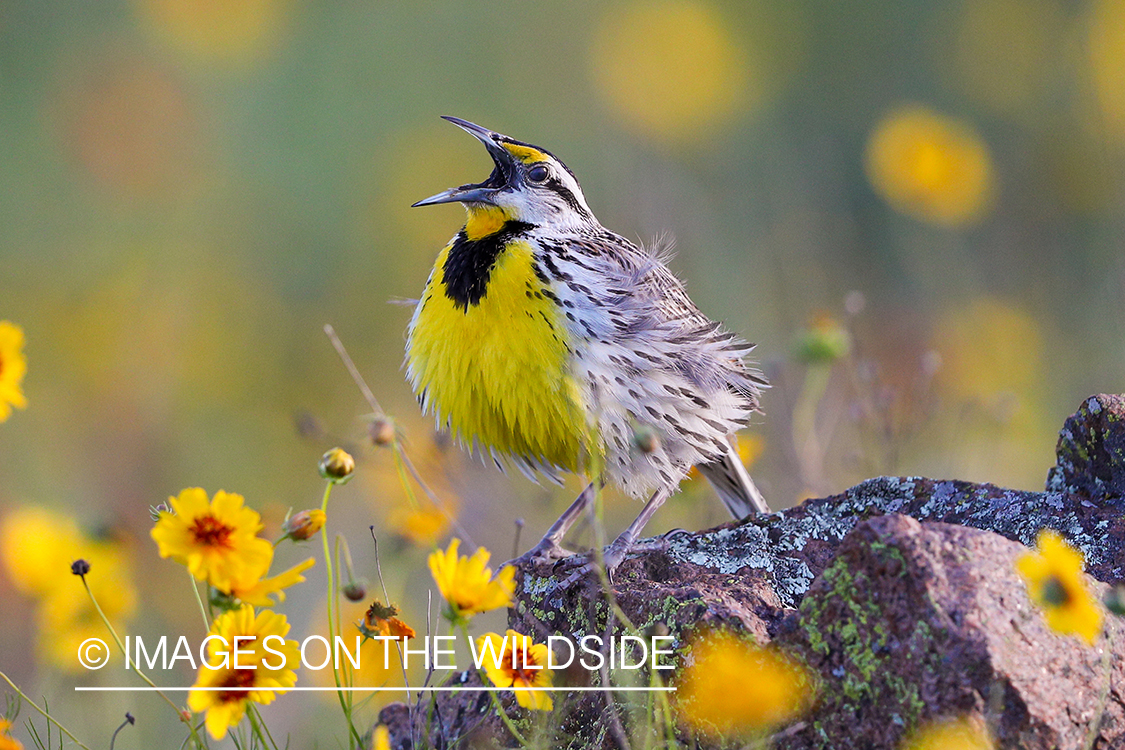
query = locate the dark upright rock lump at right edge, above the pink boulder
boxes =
[1047,394,1125,506]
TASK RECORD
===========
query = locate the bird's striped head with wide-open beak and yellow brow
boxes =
[414,117,596,226]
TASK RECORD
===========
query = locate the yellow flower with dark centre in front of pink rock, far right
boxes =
[1016,528,1105,645]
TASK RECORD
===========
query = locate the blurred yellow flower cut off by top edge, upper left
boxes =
[134,0,290,62]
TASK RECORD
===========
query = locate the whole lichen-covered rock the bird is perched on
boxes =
[375,396,1125,749]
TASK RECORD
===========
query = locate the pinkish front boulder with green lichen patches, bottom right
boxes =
[774,515,1125,750]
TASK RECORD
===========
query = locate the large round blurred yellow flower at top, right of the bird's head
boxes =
[591,0,752,141]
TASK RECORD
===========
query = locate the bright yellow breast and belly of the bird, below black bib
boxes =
[406,242,588,471]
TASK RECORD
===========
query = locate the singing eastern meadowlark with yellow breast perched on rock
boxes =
[406,117,767,570]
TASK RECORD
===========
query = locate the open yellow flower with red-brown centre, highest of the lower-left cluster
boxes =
[152,487,273,593]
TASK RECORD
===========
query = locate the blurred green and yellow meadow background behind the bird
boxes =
[0,0,1125,748]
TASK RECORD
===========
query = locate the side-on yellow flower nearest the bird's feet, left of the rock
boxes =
[429,539,515,618]
